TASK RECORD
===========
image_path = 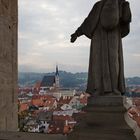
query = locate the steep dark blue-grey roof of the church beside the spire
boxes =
[41,75,55,87]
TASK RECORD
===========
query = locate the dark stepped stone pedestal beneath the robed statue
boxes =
[68,96,136,140]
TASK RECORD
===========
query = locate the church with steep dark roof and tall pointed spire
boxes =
[39,66,59,95]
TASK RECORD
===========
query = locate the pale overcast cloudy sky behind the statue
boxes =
[18,0,140,77]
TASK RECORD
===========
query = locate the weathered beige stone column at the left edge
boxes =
[0,0,18,131]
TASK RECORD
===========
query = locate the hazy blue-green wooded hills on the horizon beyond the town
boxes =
[18,71,140,88]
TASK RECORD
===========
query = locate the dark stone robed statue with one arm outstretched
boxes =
[71,0,131,95]
